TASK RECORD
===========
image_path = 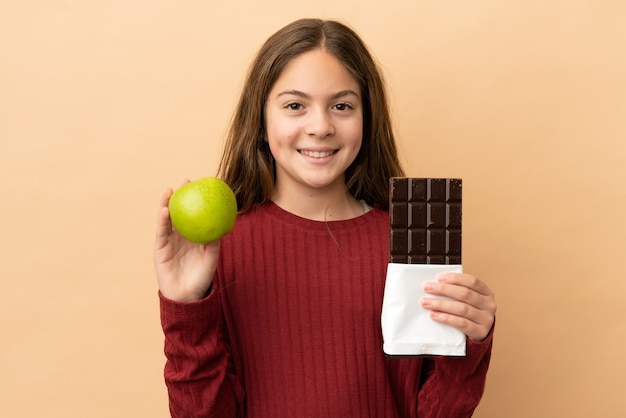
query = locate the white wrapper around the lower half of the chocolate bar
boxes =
[381,263,465,356]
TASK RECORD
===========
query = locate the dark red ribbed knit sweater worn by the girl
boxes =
[160,203,492,418]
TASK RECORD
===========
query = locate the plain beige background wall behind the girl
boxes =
[0,0,626,418]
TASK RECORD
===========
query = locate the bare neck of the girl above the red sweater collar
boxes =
[272,180,365,221]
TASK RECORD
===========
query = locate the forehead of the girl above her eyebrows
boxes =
[270,49,359,95]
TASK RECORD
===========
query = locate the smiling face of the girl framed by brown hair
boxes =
[265,49,363,198]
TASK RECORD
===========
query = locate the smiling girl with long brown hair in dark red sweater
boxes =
[154,19,496,418]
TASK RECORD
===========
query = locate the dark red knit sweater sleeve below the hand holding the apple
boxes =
[159,289,243,418]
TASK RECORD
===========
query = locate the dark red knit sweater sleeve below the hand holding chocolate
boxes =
[417,328,493,418]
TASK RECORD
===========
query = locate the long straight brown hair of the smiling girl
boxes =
[218,19,404,212]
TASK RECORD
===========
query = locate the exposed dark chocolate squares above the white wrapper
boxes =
[389,177,462,264]
